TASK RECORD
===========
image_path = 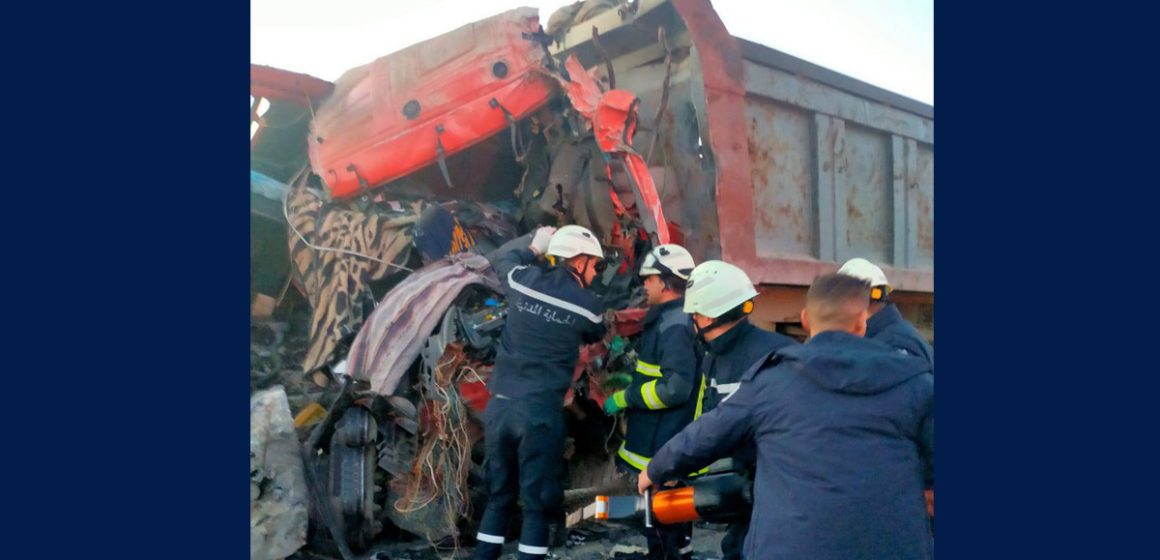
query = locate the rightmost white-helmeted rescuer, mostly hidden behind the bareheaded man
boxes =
[838,259,935,368]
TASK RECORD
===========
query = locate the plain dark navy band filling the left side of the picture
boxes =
[7,1,249,560]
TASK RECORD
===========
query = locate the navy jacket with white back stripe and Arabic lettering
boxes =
[487,234,604,405]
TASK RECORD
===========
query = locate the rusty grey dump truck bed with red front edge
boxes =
[545,0,934,294]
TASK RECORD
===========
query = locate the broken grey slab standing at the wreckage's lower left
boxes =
[249,386,309,560]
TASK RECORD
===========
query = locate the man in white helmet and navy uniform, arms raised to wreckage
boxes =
[476,225,606,560]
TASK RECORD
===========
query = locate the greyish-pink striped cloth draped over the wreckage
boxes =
[348,254,500,397]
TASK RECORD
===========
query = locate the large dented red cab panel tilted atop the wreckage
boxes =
[307,8,552,198]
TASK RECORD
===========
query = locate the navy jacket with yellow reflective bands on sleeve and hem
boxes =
[616,298,697,471]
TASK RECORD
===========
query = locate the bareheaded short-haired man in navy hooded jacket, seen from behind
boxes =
[638,274,934,560]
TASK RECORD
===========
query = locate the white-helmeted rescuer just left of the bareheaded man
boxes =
[684,261,797,560]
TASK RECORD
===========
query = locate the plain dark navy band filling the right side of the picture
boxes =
[935,2,1160,559]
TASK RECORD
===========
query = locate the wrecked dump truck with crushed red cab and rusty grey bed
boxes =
[251,0,934,555]
